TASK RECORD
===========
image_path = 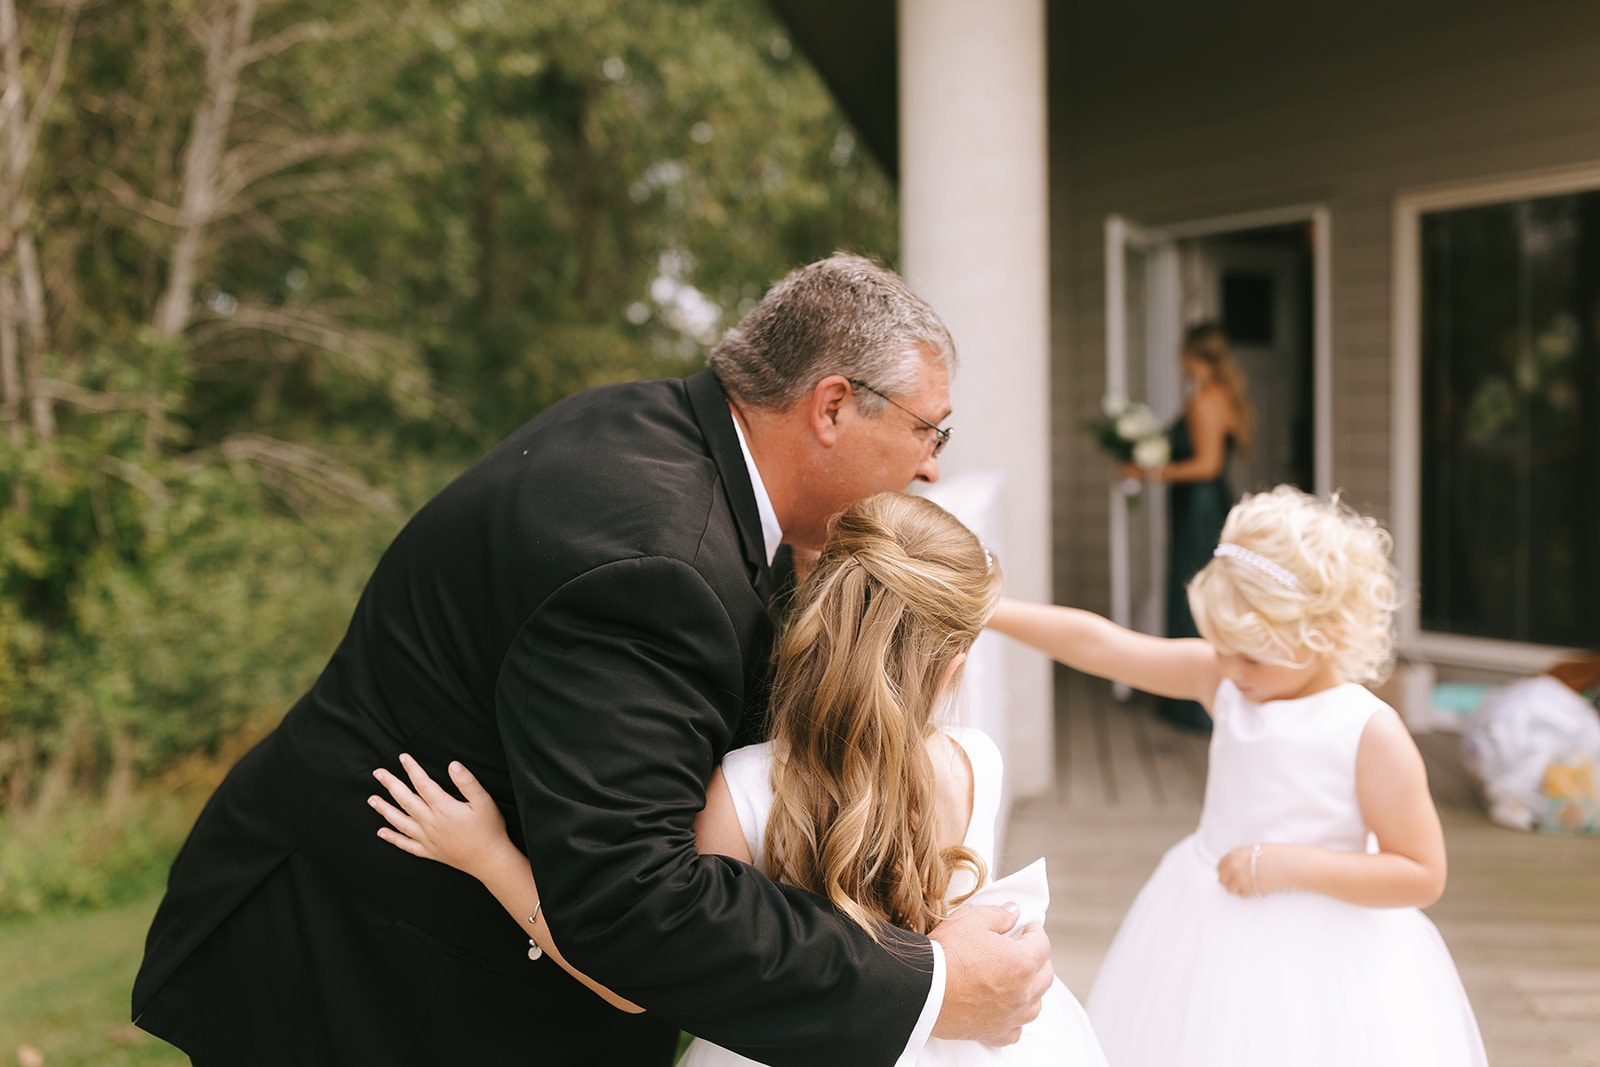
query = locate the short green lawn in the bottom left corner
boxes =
[0,893,189,1067]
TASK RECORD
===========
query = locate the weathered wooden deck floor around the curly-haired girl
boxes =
[1002,669,1600,1067]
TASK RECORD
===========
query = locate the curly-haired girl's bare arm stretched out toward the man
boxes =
[989,600,1222,710]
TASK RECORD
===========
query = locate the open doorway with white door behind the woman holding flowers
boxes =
[1106,206,1331,646]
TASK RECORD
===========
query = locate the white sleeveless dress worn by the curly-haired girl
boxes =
[1088,681,1486,1067]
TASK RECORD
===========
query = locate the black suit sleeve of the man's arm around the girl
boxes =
[496,558,933,1067]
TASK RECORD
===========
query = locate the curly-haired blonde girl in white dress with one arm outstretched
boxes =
[990,486,1485,1067]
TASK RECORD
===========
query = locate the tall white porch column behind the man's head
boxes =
[899,0,1054,795]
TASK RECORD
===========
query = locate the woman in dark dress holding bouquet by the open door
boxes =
[1123,323,1254,733]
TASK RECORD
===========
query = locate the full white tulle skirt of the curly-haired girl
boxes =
[1088,837,1486,1067]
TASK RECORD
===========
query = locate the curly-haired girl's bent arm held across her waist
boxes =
[1218,712,1448,907]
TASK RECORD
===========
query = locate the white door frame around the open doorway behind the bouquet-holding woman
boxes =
[1106,203,1333,659]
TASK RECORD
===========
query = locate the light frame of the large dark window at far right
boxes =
[1390,162,1600,673]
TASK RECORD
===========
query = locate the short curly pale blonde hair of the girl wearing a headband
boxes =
[1189,485,1400,683]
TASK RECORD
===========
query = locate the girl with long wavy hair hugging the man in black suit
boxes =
[370,493,1106,1067]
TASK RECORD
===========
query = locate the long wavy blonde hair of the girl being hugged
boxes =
[766,493,1000,937]
